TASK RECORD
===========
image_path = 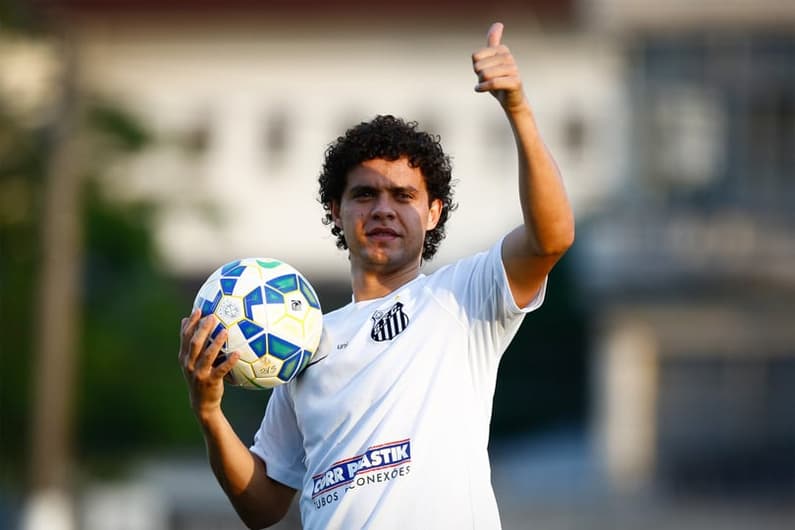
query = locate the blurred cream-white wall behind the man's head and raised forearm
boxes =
[74,21,626,277]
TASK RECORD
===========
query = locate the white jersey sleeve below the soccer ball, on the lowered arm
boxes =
[250,385,306,490]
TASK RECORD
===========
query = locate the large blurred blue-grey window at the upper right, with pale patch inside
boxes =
[630,31,795,211]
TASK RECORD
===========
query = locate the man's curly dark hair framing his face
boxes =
[318,115,457,261]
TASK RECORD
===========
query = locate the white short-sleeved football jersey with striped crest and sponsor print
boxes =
[251,237,545,530]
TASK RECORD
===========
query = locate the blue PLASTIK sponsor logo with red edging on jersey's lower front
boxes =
[312,439,411,499]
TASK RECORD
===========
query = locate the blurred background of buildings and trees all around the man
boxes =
[0,0,795,530]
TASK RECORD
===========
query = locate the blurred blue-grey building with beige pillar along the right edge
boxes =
[579,0,795,499]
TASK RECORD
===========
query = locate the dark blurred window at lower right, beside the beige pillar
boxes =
[657,352,795,495]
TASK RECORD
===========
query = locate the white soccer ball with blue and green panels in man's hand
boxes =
[193,258,323,389]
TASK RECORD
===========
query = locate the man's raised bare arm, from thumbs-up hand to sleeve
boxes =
[472,22,574,307]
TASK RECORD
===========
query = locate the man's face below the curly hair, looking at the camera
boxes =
[331,158,442,274]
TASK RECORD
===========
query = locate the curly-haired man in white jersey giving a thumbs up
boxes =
[179,23,574,529]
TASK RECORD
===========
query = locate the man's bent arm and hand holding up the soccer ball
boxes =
[179,310,295,528]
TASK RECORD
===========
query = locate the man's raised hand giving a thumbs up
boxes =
[472,22,527,113]
